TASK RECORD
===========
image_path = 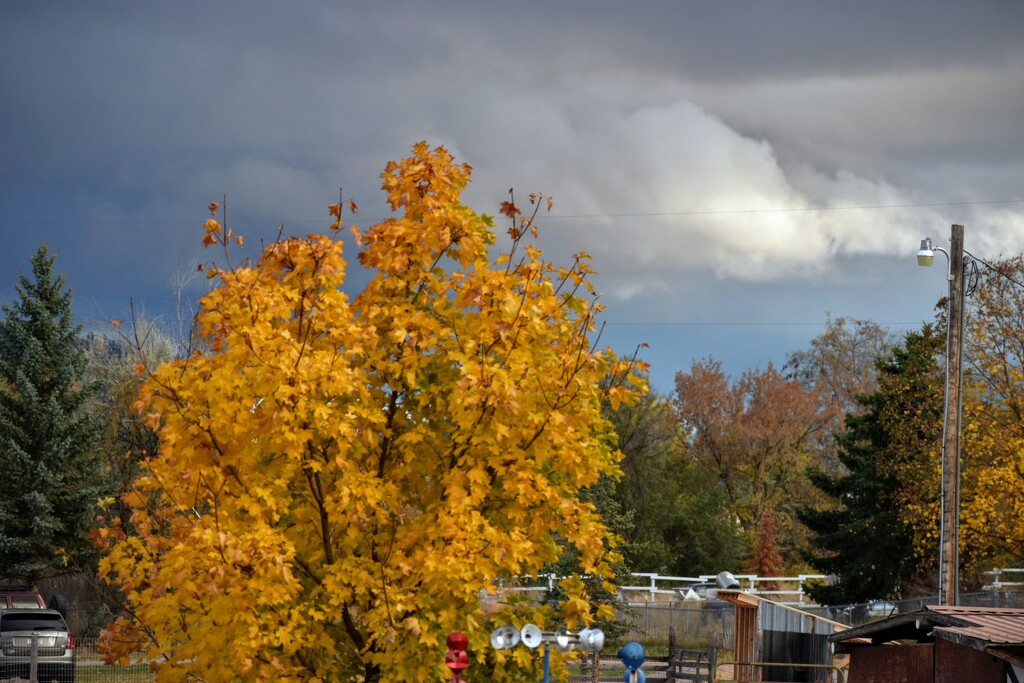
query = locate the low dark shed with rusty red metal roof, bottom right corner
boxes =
[828,605,1024,683]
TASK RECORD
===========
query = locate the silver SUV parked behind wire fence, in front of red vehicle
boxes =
[0,608,76,683]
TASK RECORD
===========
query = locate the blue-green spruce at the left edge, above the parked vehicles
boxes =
[0,245,102,581]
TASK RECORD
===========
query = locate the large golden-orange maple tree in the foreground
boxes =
[98,142,637,682]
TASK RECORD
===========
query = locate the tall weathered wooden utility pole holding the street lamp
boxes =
[939,225,964,605]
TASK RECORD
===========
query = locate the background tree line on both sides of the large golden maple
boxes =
[6,240,1024,651]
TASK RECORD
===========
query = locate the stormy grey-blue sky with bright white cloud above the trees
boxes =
[0,0,1024,392]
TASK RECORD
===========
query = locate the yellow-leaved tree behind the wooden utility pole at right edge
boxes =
[898,255,1024,591]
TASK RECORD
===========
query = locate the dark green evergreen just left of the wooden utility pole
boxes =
[800,326,943,605]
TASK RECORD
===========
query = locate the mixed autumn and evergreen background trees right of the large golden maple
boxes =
[612,256,1024,604]
